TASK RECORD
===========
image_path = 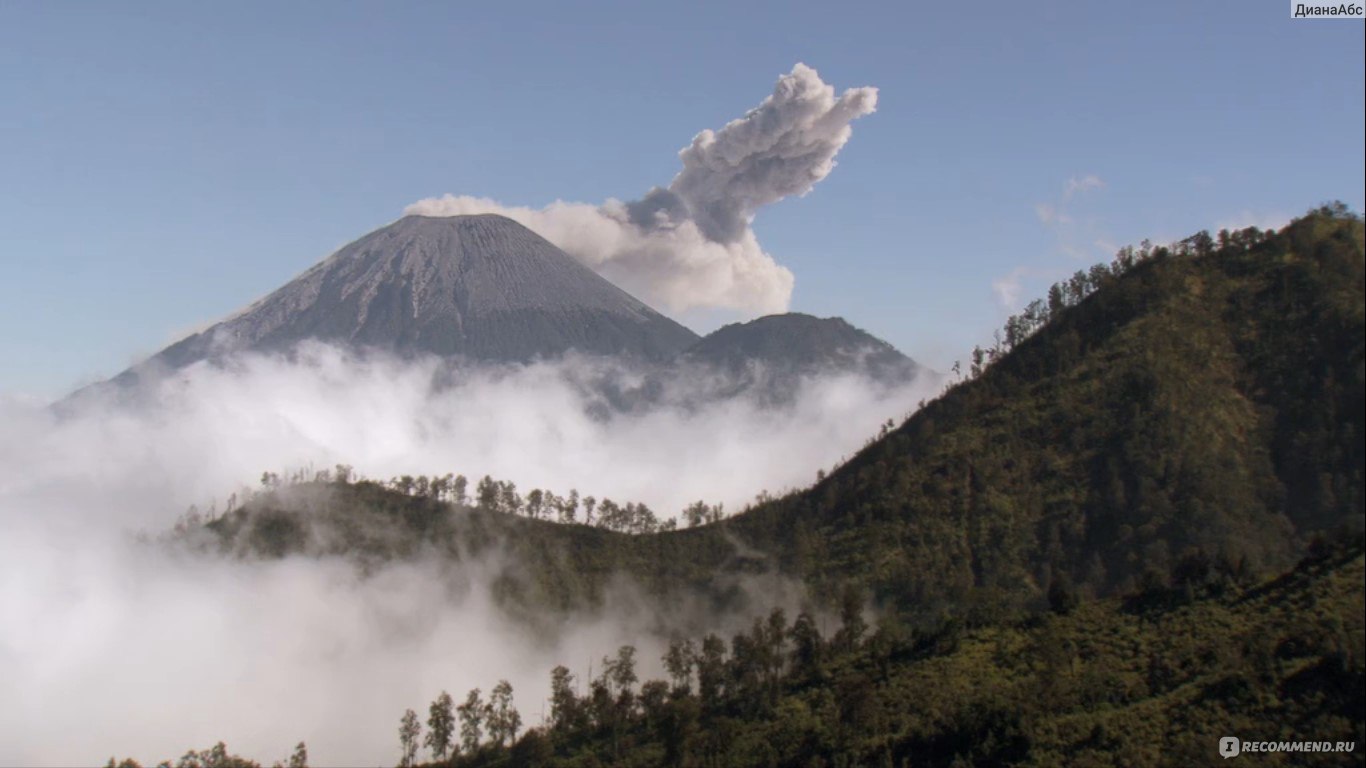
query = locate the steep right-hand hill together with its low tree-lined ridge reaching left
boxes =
[204,208,1366,623]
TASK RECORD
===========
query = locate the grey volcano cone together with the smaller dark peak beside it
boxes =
[85,215,919,404]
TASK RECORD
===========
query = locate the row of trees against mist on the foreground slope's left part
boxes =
[398,588,874,768]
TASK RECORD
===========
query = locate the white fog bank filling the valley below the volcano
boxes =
[0,344,928,765]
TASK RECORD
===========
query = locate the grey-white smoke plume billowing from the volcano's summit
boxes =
[404,64,877,313]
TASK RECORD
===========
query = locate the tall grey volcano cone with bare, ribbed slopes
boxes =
[124,215,697,377]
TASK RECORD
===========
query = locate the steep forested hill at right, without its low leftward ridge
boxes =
[732,209,1366,616]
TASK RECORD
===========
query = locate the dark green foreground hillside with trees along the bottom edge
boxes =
[109,541,1366,768]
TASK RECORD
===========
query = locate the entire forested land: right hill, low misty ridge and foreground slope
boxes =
[120,206,1366,767]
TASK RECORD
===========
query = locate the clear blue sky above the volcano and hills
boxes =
[0,0,1366,396]
